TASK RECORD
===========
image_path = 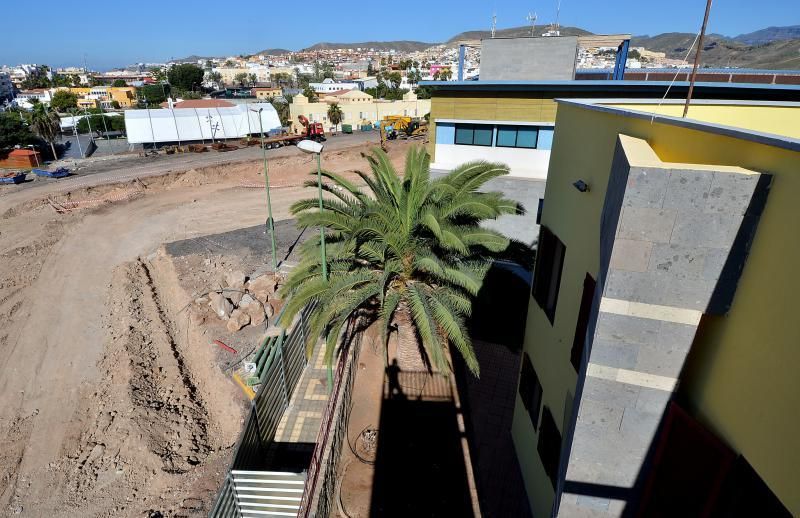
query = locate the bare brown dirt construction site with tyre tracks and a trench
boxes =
[0,135,416,517]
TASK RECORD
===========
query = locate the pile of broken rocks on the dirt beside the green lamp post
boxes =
[195,271,283,333]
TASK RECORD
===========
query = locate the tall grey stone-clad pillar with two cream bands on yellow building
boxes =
[559,137,767,516]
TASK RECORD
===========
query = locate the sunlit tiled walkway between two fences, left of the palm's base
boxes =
[275,344,328,443]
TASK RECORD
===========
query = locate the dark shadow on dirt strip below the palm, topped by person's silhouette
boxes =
[370,372,473,518]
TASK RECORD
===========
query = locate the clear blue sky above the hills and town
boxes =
[0,0,800,70]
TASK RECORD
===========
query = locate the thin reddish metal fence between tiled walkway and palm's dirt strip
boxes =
[297,322,363,518]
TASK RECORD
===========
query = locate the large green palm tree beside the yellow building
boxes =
[280,147,523,375]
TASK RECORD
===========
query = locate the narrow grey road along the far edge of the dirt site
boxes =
[0,131,380,197]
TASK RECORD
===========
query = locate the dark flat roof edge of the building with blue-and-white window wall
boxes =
[419,80,800,101]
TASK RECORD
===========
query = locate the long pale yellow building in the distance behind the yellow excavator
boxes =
[290,90,431,131]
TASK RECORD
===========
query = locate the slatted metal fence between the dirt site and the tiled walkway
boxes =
[209,306,314,518]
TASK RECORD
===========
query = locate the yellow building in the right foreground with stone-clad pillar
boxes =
[512,98,800,517]
